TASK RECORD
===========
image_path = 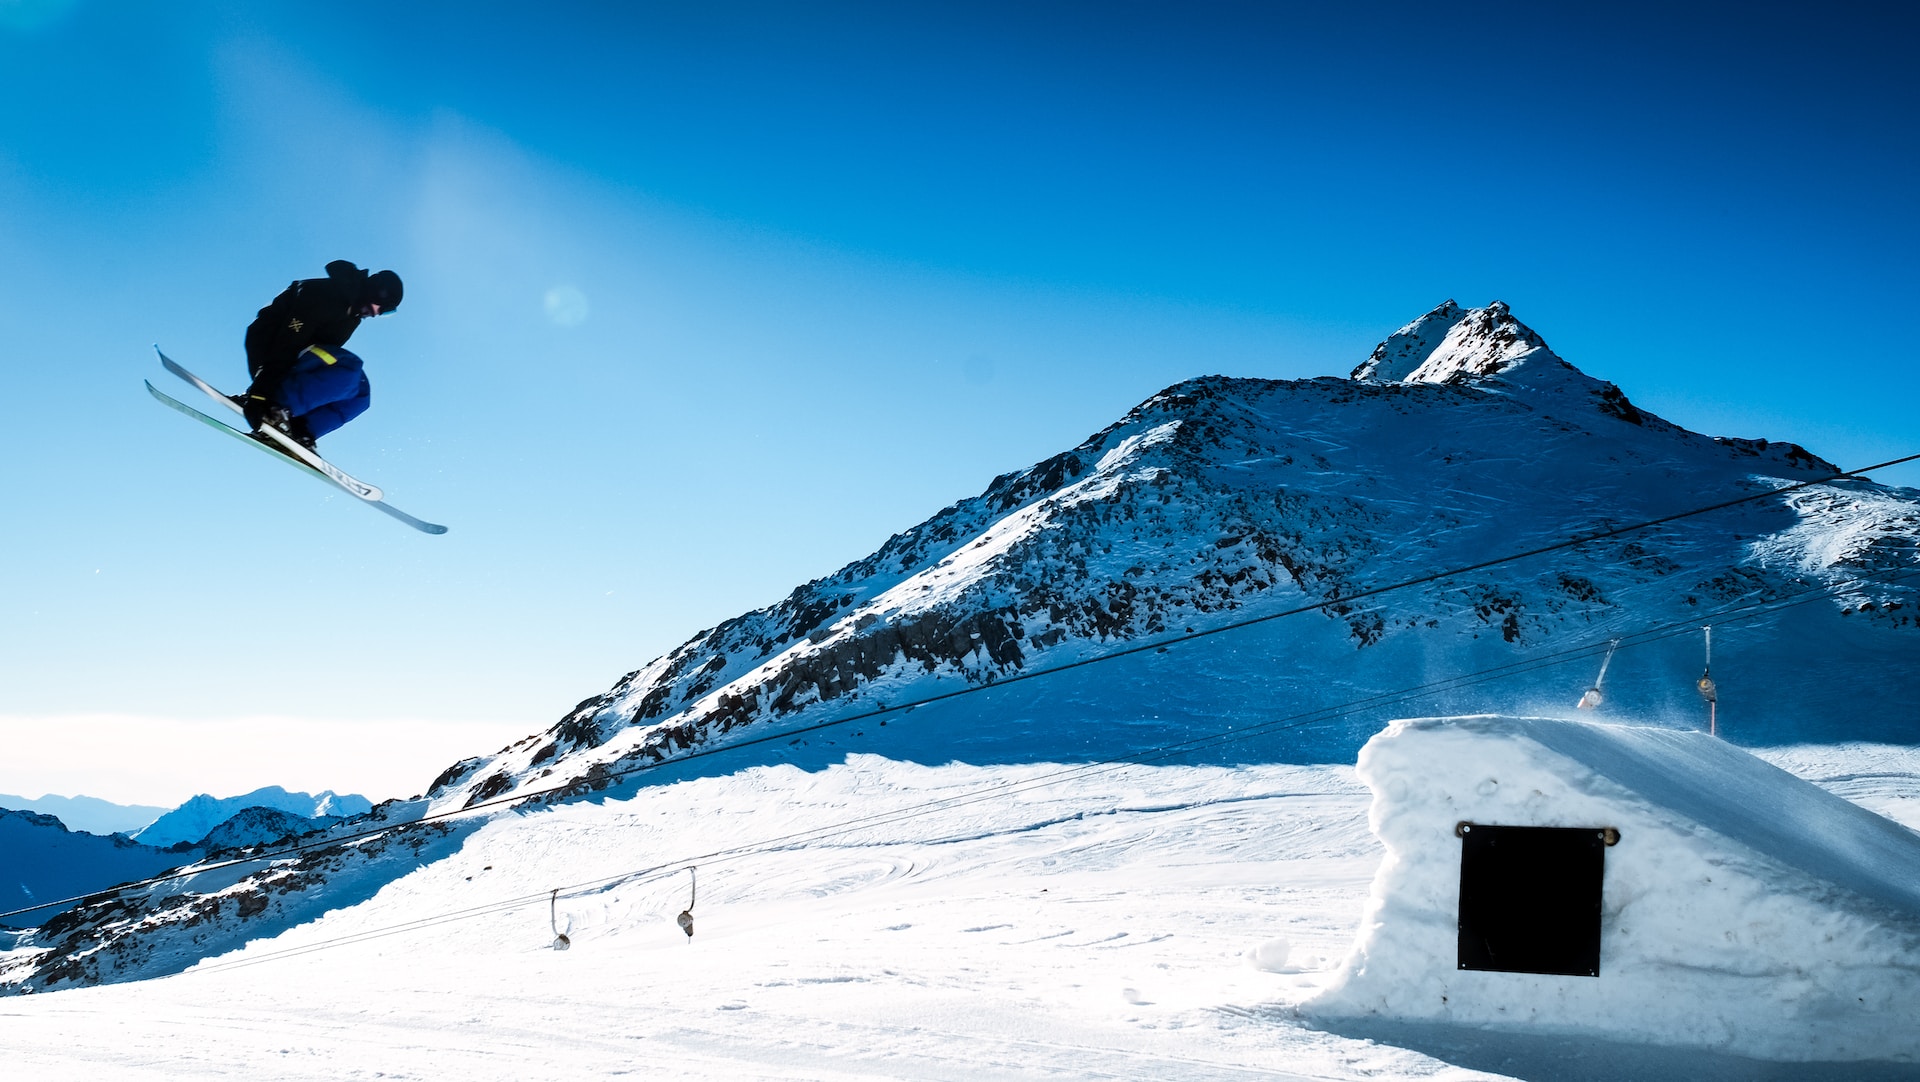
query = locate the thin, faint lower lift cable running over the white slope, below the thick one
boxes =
[145,572,1920,975]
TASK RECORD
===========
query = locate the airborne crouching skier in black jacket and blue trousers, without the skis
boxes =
[234,259,401,449]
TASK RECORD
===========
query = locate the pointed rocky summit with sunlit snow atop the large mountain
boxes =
[1354,299,1571,384]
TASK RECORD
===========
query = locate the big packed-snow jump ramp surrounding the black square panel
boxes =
[1302,716,1920,1061]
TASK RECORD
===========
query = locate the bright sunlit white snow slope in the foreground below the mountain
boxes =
[0,746,1920,1082]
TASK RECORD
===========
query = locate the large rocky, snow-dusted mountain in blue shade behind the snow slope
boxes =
[0,301,1920,992]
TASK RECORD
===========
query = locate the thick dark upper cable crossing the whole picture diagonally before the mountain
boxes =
[0,453,1920,919]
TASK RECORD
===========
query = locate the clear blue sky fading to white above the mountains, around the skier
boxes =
[0,0,1920,802]
